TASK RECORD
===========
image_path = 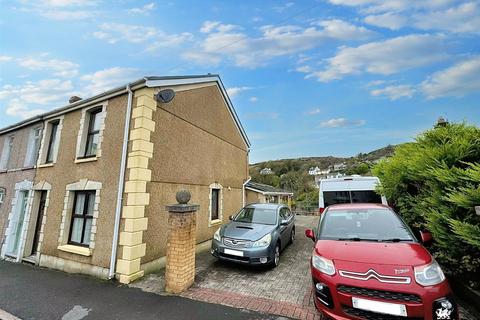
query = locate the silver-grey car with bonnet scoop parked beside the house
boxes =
[211,203,295,267]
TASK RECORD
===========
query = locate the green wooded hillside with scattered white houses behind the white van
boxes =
[250,145,395,208]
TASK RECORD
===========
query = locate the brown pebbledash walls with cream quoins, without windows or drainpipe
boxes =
[0,75,249,283]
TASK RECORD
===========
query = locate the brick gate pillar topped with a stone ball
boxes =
[165,190,200,293]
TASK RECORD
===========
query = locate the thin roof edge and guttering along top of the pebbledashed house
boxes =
[0,74,250,147]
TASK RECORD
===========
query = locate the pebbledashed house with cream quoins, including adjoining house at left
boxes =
[0,75,250,283]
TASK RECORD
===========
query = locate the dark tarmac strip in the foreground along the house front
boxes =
[0,261,281,320]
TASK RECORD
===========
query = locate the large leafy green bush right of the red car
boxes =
[373,124,480,287]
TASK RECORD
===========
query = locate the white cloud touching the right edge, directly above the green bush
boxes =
[420,56,480,99]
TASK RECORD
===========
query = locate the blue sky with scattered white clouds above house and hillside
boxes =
[0,0,480,163]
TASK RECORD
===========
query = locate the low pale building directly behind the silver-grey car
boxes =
[245,181,293,206]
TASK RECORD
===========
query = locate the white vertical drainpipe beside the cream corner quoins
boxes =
[108,84,133,279]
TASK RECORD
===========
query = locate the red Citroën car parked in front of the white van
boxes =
[305,203,458,320]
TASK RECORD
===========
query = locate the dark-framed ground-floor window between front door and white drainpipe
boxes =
[68,191,95,247]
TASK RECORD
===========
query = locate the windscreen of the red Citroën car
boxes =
[318,209,415,242]
